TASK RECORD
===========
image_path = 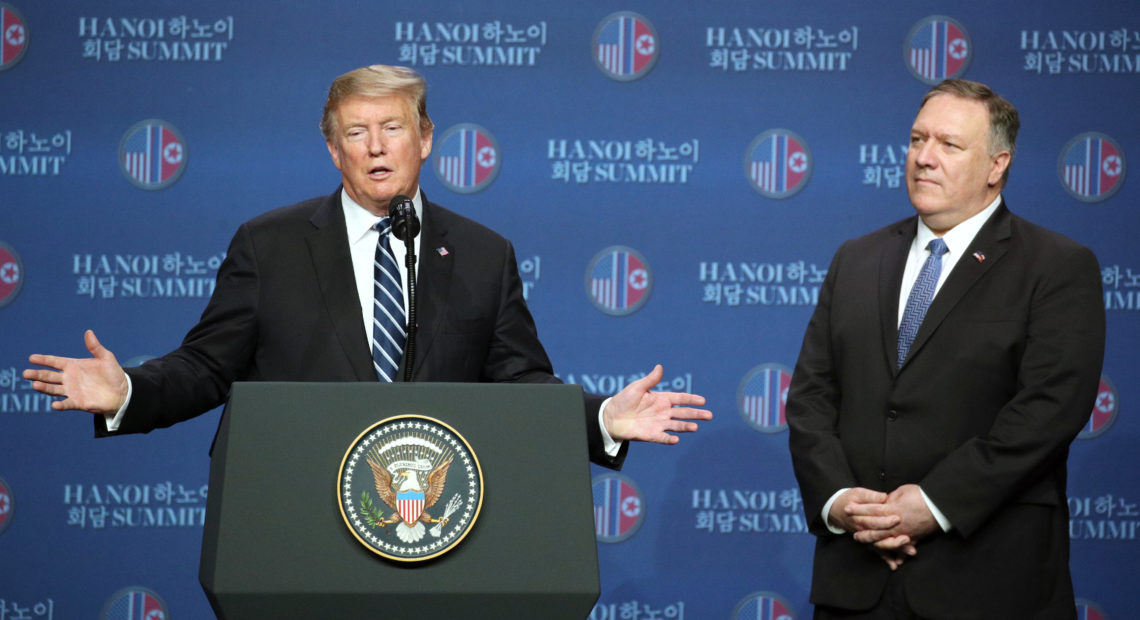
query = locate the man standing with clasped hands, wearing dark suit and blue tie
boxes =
[787,80,1105,619]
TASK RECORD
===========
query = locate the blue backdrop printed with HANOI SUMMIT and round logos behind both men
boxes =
[0,0,1140,620]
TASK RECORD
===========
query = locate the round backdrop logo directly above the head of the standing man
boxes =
[903,15,974,85]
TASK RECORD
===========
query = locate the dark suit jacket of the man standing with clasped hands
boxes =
[787,204,1105,619]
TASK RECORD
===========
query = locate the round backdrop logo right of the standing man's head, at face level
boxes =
[1057,131,1127,203]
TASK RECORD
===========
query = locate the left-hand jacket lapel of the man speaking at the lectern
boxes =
[306,188,376,381]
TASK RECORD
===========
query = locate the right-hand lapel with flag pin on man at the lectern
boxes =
[400,197,457,378]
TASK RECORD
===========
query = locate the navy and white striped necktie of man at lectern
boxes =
[372,218,407,382]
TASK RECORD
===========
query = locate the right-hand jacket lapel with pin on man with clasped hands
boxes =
[906,202,1010,369]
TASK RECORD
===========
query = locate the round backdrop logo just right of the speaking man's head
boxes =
[434,123,502,194]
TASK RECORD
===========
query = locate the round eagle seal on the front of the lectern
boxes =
[336,415,483,562]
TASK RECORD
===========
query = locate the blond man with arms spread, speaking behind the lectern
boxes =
[24,65,711,467]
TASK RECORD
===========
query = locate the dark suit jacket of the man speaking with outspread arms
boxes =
[102,189,628,467]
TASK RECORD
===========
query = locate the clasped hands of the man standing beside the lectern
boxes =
[828,484,938,571]
